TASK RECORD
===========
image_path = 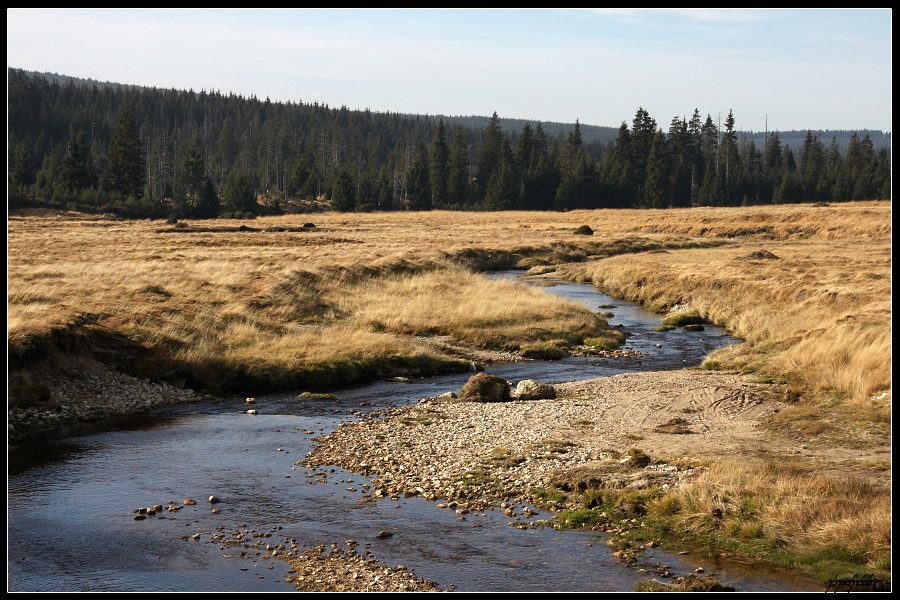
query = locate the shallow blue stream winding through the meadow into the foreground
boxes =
[7,271,821,592]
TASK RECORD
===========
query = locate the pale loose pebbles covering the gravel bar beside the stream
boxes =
[295,378,698,510]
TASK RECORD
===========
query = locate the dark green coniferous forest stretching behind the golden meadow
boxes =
[8,69,891,218]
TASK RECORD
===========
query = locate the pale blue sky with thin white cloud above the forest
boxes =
[6,9,892,131]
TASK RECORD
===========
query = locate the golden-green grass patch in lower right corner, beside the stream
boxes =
[649,461,891,578]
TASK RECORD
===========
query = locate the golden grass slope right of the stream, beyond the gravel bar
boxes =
[567,227,891,406]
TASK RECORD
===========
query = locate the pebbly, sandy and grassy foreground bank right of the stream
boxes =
[298,370,890,580]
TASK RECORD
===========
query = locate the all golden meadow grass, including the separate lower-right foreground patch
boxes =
[7,202,891,577]
